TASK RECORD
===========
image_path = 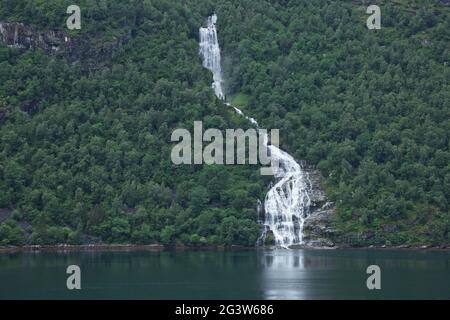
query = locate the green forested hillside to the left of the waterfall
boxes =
[0,0,268,245]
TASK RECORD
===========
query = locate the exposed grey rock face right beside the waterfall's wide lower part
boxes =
[303,167,336,247]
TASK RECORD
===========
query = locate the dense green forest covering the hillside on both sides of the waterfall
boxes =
[0,0,450,245]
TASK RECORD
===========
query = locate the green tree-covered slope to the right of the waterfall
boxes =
[215,0,450,244]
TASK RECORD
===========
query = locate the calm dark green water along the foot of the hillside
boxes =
[0,250,450,299]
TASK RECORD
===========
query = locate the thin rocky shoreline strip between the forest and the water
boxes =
[0,244,450,254]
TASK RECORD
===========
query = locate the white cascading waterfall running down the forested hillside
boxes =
[200,14,311,248]
